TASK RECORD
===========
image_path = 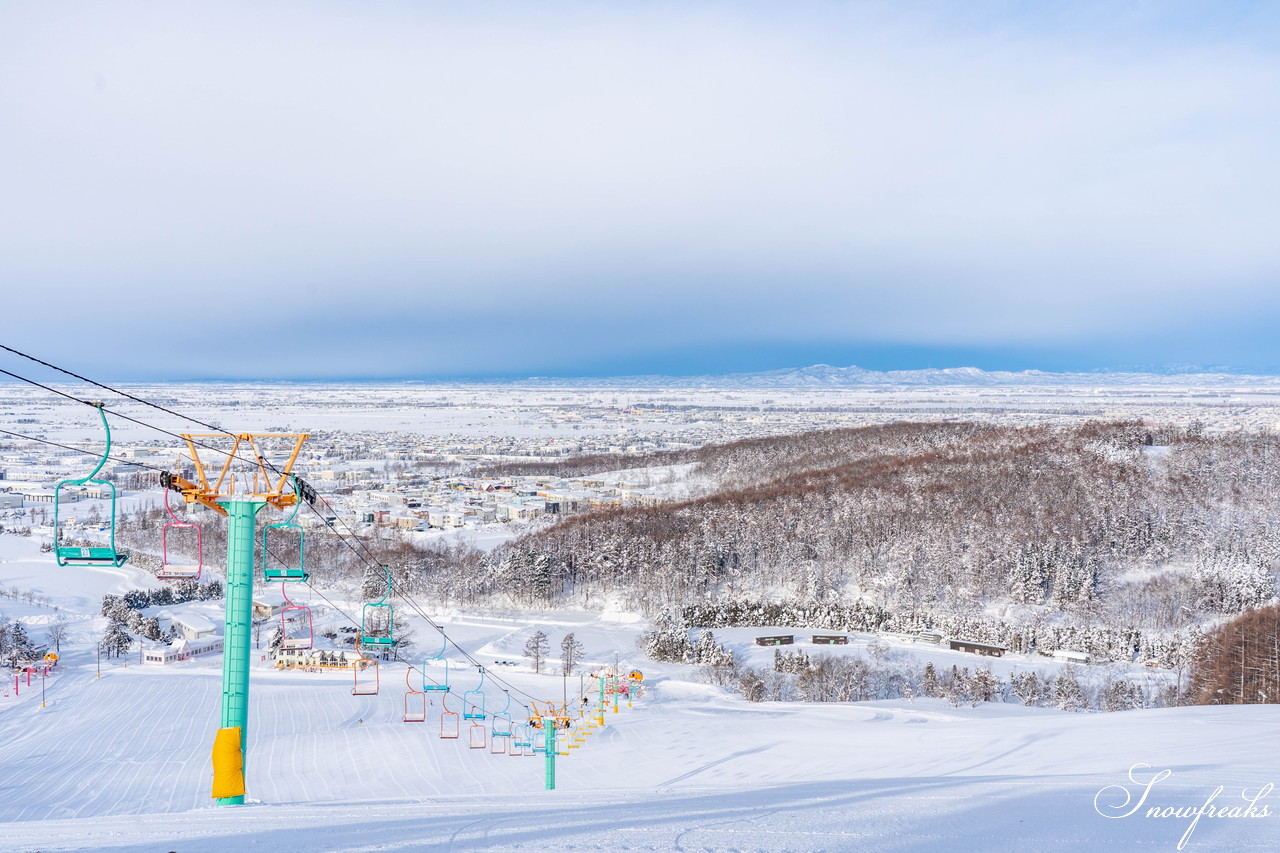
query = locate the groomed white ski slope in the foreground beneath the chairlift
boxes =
[0,537,1280,853]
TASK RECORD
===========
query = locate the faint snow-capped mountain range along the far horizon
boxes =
[509,364,1280,388]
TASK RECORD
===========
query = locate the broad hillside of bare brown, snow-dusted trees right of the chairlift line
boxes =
[488,423,1280,658]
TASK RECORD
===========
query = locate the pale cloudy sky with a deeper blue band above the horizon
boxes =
[0,0,1280,379]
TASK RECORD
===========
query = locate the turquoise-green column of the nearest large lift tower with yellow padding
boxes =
[215,498,266,806]
